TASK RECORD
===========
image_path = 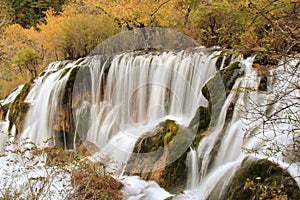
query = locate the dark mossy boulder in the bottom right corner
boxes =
[224,159,300,200]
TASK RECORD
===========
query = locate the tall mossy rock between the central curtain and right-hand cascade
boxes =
[189,60,243,147]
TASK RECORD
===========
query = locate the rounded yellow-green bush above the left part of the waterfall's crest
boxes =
[57,14,119,58]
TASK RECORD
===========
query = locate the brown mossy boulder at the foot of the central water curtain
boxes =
[125,120,193,193]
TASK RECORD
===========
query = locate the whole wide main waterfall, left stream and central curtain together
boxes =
[1,48,220,164]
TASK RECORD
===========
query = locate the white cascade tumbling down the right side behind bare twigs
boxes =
[176,56,300,199]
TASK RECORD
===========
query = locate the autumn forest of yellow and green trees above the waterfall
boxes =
[0,0,300,98]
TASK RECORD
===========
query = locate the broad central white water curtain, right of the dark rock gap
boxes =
[73,49,219,170]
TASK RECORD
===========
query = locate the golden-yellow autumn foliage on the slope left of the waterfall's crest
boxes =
[0,0,119,98]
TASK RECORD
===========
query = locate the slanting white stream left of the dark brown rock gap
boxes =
[21,62,76,146]
